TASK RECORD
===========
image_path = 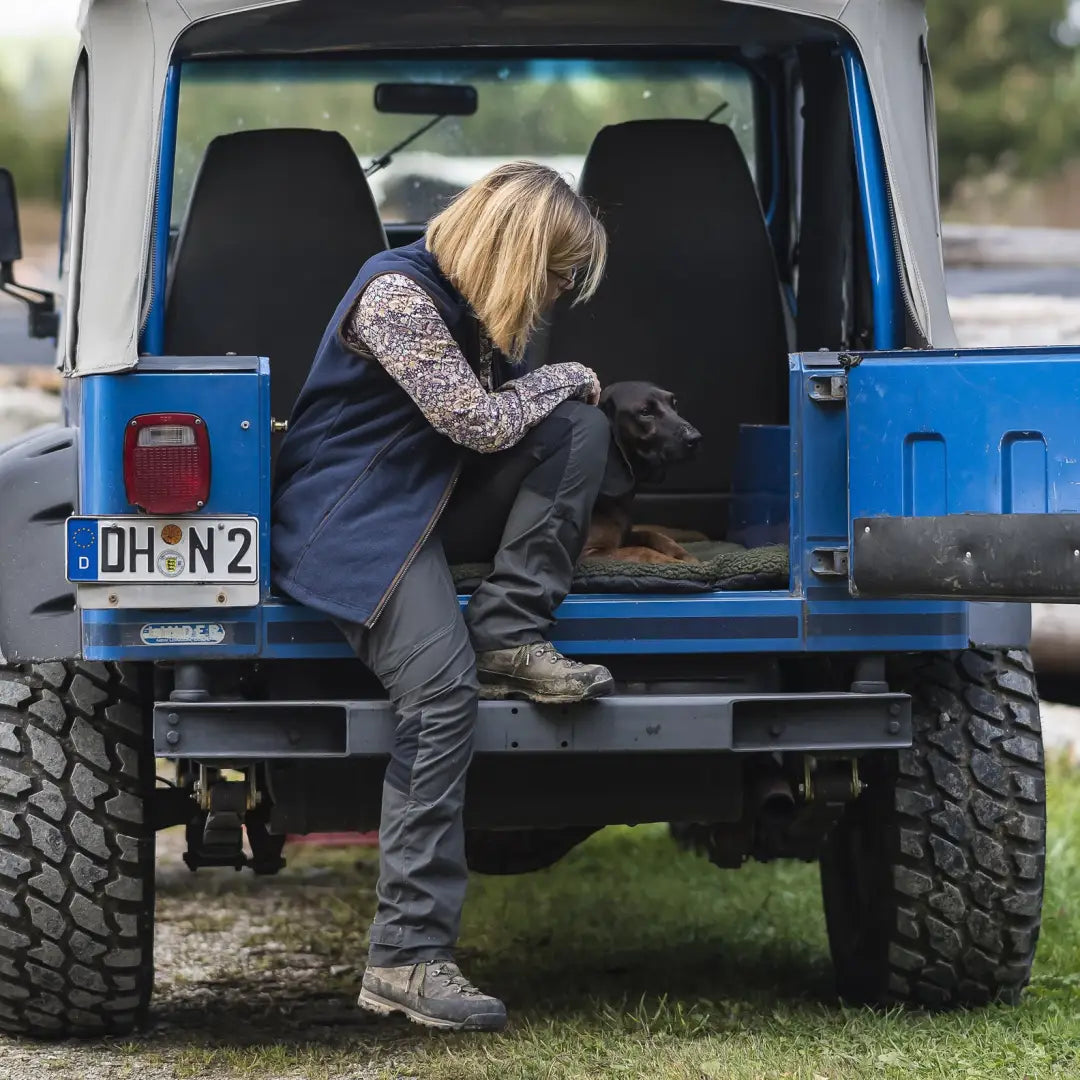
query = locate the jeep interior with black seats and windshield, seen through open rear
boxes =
[157,35,872,589]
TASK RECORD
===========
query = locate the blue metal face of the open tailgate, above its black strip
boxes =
[847,348,1080,518]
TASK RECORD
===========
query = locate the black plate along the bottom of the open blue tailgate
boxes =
[851,513,1080,602]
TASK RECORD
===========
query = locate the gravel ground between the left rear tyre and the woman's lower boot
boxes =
[0,829,393,1080]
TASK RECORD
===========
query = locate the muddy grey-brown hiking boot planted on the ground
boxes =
[357,960,507,1031]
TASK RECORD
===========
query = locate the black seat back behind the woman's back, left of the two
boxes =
[165,129,387,419]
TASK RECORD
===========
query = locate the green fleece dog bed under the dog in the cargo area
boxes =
[450,540,788,593]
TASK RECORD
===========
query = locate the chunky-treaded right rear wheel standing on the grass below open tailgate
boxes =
[821,650,1047,1009]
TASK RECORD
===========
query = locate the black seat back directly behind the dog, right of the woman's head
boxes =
[545,120,787,535]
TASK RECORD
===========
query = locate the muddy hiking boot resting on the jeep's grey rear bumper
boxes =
[476,642,615,705]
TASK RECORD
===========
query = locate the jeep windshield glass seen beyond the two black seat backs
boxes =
[172,58,758,225]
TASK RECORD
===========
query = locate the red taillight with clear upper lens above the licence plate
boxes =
[124,413,210,514]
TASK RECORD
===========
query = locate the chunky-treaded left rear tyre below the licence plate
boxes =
[0,662,153,1038]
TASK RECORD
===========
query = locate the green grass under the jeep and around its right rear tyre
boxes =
[130,766,1080,1080]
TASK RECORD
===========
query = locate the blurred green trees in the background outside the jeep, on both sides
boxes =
[0,0,1080,226]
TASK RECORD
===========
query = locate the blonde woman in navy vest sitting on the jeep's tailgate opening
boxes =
[272,162,612,1029]
